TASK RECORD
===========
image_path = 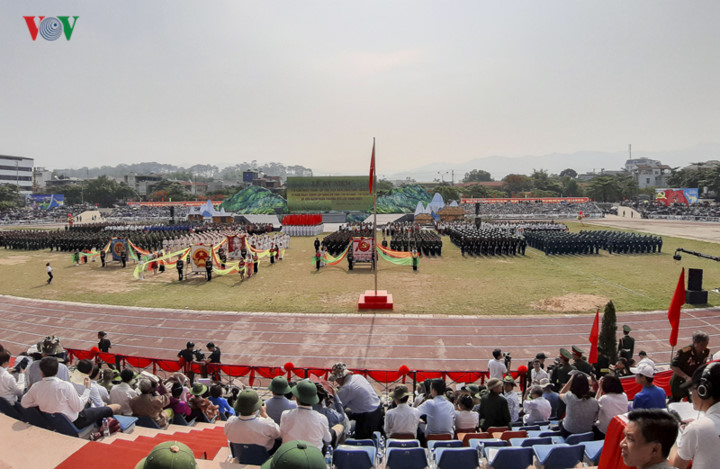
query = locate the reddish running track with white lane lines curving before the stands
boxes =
[0,295,720,371]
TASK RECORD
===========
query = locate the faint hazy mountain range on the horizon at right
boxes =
[386,143,720,182]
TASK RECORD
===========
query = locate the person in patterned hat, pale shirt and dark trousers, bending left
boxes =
[330,363,384,439]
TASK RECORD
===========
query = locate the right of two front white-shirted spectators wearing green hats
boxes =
[280,379,332,450]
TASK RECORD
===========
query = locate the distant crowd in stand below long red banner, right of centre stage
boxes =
[460,201,603,219]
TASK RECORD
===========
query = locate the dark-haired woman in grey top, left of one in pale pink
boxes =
[560,371,600,438]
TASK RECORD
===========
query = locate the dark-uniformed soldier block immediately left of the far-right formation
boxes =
[445,223,527,256]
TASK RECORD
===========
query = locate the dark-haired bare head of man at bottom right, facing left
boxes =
[620,409,680,469]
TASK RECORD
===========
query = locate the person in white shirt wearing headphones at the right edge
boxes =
[670,362,720,469]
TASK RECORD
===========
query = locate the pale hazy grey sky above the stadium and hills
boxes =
[0,0,720,174]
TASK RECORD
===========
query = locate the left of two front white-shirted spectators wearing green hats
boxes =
[225,389,280,451]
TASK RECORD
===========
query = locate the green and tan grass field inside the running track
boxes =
[0,219,720,315]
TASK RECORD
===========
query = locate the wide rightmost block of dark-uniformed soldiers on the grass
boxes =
[525,230,662,255]
